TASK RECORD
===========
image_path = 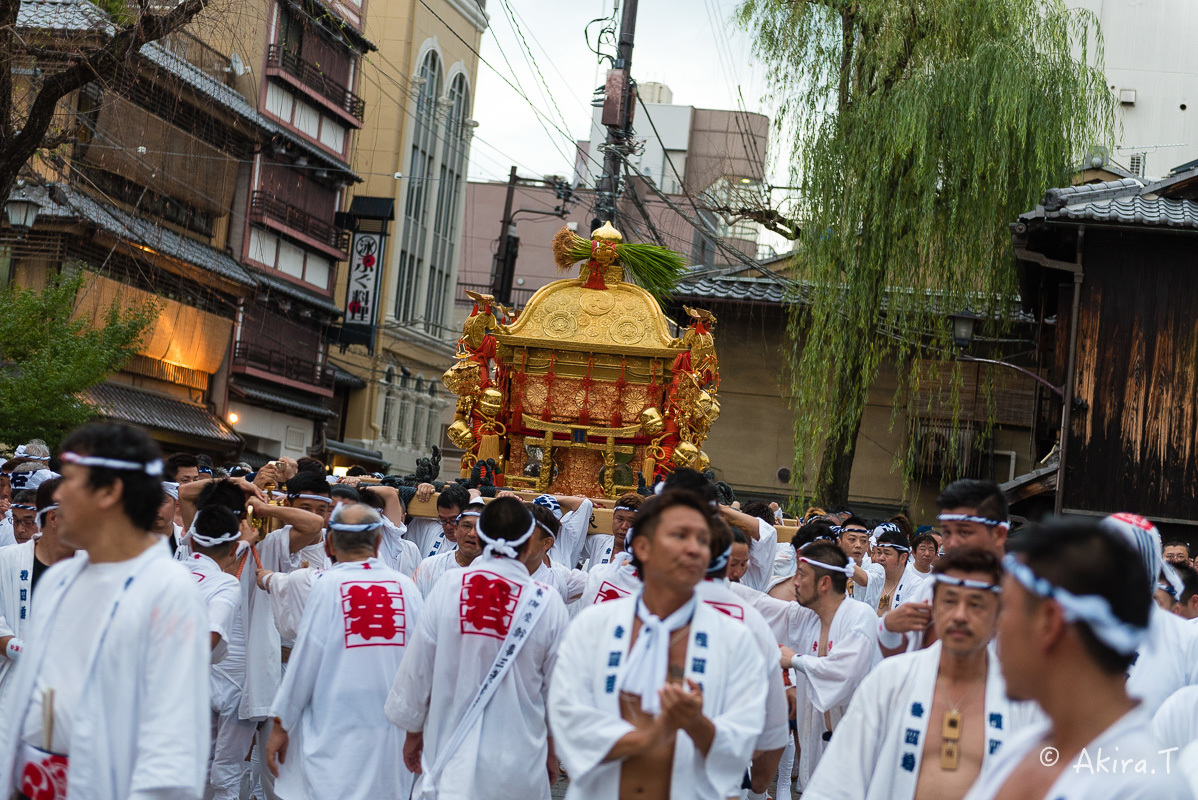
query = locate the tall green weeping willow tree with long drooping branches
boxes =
[738,0,1114,504]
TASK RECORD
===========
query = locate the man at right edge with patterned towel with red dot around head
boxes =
[1102,514,1198,716]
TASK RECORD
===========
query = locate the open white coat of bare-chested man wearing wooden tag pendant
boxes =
[803,642,1041,800]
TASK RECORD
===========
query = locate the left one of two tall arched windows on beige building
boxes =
[395,50,441,320]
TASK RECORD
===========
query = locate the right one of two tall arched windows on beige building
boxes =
[424,73,471,335]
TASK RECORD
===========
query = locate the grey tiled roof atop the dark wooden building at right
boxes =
[1019,174,1198,229]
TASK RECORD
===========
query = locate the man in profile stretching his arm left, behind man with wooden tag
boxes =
[732,541,881,792]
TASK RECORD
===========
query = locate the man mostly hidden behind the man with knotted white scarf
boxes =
[695,519,793,800]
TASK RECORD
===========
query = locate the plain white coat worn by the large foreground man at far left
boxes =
[0,546,211,800]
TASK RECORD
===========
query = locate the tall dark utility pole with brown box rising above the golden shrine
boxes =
[591,0,636,229]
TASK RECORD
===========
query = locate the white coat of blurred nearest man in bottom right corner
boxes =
[966,708,1193,800]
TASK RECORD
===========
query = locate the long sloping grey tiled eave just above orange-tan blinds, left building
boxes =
[30,184,258,286]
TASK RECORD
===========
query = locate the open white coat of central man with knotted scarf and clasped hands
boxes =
[548,594,767,800]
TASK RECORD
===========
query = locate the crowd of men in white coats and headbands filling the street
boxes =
[0,424,1198,800]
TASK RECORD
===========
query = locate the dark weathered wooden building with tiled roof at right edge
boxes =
[1011,168,1198,538]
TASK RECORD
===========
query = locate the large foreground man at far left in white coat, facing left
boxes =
[0,424,211,800]
